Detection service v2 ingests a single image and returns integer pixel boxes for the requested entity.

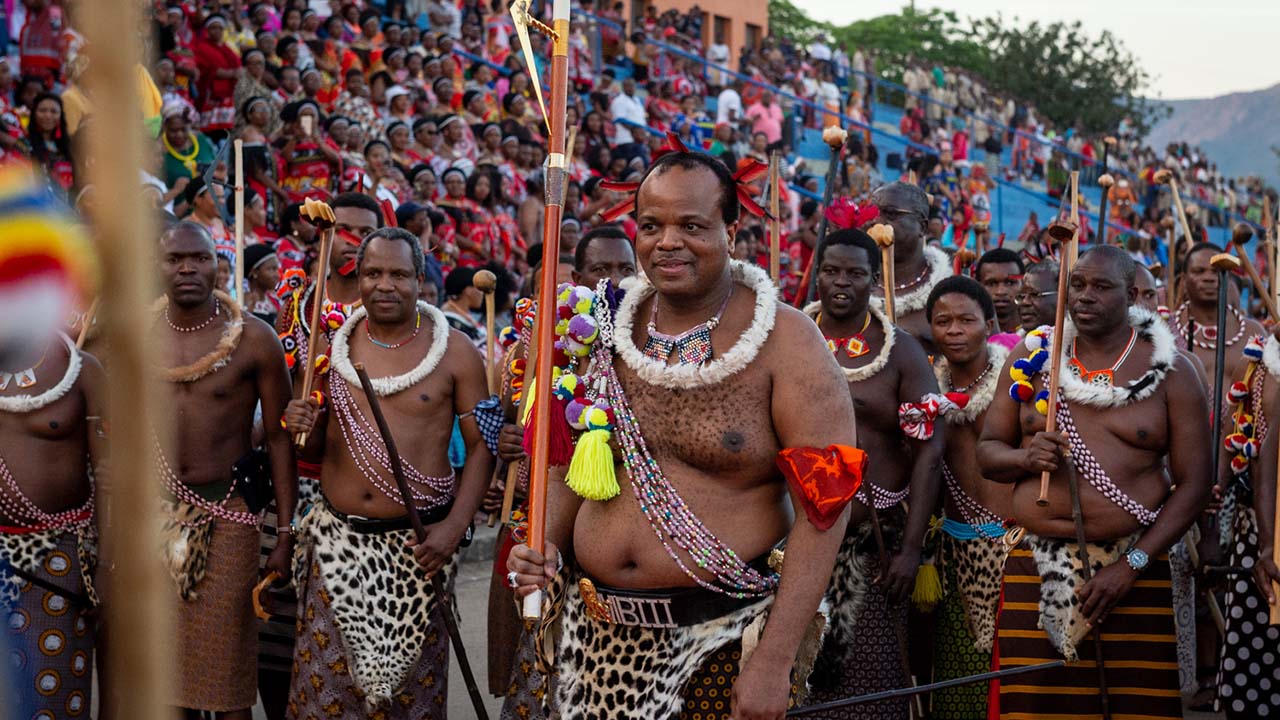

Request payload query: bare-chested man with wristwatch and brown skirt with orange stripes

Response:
[978,246,1211,717]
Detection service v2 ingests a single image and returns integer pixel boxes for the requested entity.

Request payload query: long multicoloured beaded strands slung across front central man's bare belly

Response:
[593,328,778,598]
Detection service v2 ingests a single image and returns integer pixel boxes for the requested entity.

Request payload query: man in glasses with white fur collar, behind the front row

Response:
[872,182,952,351]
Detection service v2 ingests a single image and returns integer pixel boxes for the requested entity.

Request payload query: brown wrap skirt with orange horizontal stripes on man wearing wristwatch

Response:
[997,541,1183,720]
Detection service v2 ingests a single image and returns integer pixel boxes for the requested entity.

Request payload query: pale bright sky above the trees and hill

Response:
[794,0,1280,100]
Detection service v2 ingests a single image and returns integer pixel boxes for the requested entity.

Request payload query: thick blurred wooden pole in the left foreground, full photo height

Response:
[77,1,177,720]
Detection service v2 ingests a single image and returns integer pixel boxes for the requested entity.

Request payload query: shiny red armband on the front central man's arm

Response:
[777,445,867,530]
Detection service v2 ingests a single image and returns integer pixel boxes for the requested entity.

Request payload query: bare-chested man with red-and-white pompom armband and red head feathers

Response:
[805,229,945,717]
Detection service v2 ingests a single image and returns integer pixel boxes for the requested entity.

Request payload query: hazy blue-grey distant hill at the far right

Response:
[1148,85,1280,184]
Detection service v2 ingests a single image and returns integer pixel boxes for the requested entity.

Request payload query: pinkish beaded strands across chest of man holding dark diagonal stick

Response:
[329,361,457,510]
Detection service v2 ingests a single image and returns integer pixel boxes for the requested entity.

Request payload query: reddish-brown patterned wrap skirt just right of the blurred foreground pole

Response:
[173,496,261,712]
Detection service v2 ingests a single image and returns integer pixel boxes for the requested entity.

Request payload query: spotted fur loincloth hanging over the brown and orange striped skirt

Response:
[1027,533,1139,662]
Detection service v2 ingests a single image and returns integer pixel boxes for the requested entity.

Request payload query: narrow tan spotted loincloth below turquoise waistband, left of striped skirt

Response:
[943,536,1010,652]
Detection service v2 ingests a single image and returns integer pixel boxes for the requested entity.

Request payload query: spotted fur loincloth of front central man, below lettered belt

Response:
[556,585,773,720]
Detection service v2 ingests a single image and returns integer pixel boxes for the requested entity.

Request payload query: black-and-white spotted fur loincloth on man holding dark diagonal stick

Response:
[293,502,458,711]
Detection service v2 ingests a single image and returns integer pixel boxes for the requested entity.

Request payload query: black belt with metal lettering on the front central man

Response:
[577,545,772,628]
